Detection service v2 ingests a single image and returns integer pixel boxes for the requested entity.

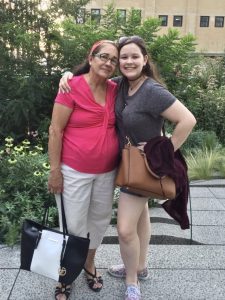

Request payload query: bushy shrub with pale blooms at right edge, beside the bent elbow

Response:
[174,57,225,145]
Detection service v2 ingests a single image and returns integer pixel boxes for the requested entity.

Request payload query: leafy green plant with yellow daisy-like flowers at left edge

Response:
[0,137,57,245]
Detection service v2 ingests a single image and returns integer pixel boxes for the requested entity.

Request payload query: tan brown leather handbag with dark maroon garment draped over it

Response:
[115,142,176,199]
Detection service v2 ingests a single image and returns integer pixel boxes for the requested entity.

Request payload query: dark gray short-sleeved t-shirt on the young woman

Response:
[115,78,176,147]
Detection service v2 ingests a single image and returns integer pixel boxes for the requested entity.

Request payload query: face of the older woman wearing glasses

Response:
[89,43,118,78]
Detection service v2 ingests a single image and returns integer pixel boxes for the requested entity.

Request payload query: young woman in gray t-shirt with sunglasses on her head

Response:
[60,36,196,300]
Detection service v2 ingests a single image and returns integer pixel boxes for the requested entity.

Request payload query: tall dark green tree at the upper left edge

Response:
[0,0,88,138]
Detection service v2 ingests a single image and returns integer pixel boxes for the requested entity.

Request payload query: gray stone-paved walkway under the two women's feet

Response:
[0,180,225,300]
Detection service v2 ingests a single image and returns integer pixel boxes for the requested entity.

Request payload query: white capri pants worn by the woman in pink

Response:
[55,164,116,249]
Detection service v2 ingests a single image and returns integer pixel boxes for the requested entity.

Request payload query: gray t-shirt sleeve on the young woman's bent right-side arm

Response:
[144,82,176,117]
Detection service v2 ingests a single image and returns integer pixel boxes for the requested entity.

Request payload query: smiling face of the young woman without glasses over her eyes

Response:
[119,43,148,80]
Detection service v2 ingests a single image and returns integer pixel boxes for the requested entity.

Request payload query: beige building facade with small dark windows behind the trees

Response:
[86,0,225,55]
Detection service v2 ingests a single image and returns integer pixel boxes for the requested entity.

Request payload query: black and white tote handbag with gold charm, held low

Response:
[20,195,90,284]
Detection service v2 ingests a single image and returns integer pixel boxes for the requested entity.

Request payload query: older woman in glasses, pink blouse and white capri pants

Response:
[48,40,119,300]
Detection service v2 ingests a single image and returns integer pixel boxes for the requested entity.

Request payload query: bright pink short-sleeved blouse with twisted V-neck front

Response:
[55,75,119,174]
